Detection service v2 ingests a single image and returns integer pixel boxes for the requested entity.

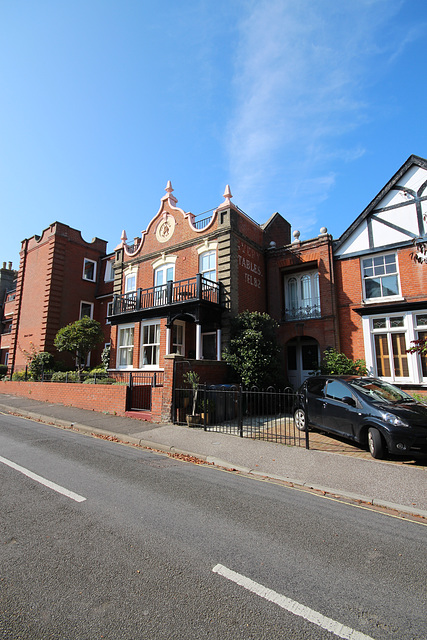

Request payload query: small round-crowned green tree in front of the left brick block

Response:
[54,316,104,370]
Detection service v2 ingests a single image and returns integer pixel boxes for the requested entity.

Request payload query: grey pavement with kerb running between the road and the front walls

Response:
[0,394,427,518]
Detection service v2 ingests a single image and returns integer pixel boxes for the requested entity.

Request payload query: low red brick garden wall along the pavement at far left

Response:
[0,381,127,416]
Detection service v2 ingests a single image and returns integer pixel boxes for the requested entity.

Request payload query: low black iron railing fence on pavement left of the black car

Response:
[172,384,309,449]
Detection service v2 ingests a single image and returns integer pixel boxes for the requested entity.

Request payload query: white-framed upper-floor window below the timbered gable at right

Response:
[362,253,400,300]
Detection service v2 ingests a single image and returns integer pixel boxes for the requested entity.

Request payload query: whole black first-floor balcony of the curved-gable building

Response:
[108,274,221,324]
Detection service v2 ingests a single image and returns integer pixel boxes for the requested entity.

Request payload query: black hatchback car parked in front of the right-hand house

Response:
[294,376,427,458]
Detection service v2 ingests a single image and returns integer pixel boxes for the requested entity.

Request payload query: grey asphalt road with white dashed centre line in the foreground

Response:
[0,415,427,640]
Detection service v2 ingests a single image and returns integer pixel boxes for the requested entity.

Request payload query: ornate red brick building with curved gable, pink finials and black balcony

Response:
[110,182,290,372]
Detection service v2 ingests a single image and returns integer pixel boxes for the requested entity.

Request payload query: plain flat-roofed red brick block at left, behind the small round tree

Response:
[1,222,113,371]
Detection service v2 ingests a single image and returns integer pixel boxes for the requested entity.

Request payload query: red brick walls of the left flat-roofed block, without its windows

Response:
[10,222,112,370]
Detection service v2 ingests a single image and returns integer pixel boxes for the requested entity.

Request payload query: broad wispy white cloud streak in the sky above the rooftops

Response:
[228,0,414,234]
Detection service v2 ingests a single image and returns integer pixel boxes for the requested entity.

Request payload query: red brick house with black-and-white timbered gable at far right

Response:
[334,156,427,386]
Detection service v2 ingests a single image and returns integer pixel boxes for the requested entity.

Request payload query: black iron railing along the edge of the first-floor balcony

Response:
[112,273,220,316]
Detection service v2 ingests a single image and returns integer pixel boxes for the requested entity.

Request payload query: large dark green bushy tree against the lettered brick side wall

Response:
[223,311,283,387]
